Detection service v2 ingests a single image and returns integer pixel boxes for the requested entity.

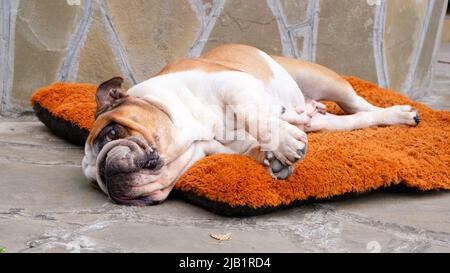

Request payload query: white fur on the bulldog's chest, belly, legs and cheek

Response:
[83,45,417,200]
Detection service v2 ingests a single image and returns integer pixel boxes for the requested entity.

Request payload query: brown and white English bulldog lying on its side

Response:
[82,44,420,205]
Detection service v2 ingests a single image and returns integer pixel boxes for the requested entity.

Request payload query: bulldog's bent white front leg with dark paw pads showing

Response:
[227,85,307,179]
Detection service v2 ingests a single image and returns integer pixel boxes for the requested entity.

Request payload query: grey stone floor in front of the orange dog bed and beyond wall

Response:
[0,45,450,252]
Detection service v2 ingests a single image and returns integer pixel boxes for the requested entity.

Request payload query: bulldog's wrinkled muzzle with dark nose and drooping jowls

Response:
[97,137,164,206]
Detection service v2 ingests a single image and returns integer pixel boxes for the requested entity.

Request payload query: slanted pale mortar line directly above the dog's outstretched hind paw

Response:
[402,0,435,95]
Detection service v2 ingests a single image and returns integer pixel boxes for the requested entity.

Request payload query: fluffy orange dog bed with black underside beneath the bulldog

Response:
[31,77,450,216]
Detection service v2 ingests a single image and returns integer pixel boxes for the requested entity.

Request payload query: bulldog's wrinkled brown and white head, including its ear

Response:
[82,78,175,205]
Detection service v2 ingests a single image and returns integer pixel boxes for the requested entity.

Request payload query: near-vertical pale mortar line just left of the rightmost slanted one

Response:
[373,0,390,88]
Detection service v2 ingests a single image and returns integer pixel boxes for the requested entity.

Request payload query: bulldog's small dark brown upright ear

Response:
[95,77,128,117]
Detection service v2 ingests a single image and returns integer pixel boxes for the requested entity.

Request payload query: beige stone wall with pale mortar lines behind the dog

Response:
[0,0,447,115]
